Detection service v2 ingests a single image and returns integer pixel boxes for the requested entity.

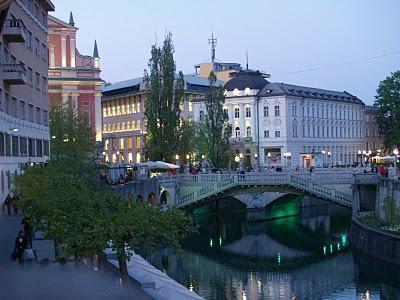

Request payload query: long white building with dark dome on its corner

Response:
[194,70,365,167]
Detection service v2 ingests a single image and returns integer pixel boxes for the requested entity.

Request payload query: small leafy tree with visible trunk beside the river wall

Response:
[103,194,195,282]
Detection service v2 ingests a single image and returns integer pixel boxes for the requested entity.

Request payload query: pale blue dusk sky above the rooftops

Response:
[53,0,400,104]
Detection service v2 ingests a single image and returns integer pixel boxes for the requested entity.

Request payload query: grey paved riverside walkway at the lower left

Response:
[0,210,152,300]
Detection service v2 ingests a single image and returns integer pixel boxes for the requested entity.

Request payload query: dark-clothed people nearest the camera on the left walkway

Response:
[11,217,36,266]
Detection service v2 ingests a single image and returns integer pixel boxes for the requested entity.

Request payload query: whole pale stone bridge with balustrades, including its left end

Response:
[113,170,354,208]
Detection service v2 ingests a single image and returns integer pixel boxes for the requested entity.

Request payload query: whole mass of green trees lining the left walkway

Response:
[15,101,194,282]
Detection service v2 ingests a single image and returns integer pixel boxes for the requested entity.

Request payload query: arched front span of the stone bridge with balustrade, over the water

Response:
[175,173,353,208]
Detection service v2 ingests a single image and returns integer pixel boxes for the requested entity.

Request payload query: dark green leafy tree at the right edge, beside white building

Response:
[374,71,400,150]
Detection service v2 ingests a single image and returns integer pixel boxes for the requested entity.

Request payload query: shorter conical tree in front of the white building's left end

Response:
[197,72,232,168]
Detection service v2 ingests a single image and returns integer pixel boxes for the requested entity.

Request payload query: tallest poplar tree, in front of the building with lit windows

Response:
[144,33,184,162]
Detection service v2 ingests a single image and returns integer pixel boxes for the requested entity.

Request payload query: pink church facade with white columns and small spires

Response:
[48,13,104,141]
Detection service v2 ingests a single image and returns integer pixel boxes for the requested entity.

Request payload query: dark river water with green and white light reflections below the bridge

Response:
[149,195,400,299]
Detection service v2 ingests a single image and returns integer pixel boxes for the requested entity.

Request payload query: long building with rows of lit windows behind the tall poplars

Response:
[102,75,217,164]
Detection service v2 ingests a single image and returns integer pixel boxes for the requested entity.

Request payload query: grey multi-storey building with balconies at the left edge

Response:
[0,0,54,202]
